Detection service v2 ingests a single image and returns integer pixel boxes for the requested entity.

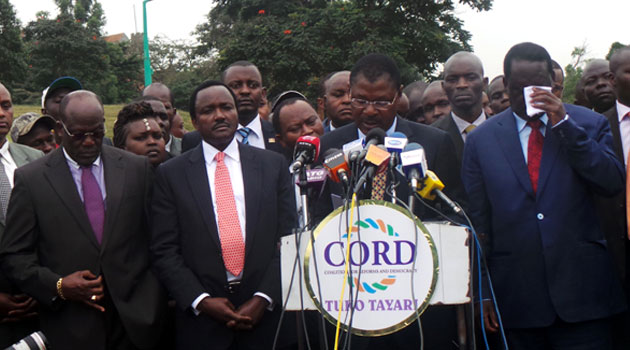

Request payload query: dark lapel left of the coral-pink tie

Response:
[184,143,221,250]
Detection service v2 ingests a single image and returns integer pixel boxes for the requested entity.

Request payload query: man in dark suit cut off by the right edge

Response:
[596,47,630,349]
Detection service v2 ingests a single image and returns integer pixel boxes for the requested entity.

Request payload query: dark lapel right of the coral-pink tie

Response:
[238,143,262,260]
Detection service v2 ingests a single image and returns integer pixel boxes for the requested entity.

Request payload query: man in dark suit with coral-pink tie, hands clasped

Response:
[151,81,296,349]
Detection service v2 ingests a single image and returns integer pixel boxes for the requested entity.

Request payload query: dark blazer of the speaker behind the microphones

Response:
[315,117,464,220]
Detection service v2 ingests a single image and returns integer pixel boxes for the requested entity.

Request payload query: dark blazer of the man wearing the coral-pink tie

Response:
[151,144,296,349]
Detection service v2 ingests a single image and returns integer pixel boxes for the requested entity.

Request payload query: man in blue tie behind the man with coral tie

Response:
[182,61,282,153]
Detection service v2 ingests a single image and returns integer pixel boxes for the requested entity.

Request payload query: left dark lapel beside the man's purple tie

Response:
[44,148,100,249]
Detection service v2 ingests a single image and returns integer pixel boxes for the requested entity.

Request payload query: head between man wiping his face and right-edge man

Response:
[580,59,616,113]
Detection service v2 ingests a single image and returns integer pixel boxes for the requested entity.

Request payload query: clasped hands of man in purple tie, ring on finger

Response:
[61,270,105,312]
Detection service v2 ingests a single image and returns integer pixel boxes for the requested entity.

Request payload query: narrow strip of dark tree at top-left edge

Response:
[0,0,26,89]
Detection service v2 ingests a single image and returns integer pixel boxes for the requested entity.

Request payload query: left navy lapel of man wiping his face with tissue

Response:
[493,108,534,195]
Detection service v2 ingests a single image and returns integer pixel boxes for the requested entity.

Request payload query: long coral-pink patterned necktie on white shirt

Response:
[214,152,245,276]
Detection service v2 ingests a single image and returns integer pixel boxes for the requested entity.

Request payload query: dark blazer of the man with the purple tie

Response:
[0,146,165,349]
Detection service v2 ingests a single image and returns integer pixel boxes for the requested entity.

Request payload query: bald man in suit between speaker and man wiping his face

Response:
[431,51,487,164]
